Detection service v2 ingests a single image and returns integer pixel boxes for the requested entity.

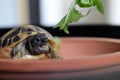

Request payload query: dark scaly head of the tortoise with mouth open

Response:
[27,33,50,55]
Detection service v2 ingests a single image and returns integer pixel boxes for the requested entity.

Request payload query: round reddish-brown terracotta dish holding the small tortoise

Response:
[0,38,120,80]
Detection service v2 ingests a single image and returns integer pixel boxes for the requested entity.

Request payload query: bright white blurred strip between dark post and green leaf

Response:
[40,0,62,26]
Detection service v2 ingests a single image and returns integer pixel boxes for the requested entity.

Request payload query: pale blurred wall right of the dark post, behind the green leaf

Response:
[40,0,120,26]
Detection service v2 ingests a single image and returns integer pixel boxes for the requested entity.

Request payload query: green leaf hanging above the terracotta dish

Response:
[55,0,104,34]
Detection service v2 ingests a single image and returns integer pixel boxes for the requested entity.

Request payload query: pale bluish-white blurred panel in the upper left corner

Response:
[0,0,18,27]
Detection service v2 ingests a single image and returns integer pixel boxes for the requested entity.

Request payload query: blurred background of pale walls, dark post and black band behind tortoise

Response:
[0,0,120,36]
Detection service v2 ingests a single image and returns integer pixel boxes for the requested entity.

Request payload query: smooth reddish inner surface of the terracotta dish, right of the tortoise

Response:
[60,38,120,59]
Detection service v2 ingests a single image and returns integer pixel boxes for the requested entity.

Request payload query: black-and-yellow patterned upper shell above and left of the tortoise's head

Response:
[0,25,37,48]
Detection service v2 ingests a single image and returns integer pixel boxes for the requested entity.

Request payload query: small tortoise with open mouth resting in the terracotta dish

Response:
[0,25,61,59]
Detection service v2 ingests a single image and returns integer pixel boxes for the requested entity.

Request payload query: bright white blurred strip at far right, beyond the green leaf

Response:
[104,0,120,25]
